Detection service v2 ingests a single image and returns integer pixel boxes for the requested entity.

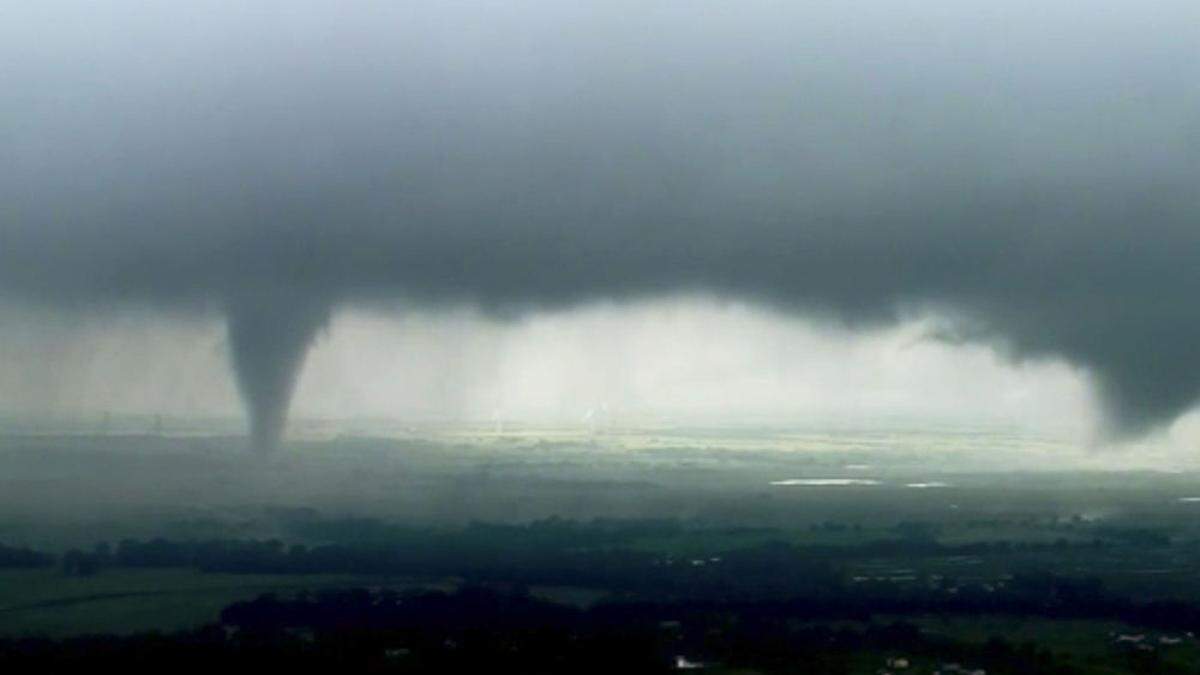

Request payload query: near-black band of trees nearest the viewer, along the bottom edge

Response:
[0,587,1142,675]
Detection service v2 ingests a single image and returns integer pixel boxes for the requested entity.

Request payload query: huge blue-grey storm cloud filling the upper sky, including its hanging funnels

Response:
[0,1,1200,444]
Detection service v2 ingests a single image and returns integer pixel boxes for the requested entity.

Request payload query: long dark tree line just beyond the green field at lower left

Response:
[54,525,1123,578]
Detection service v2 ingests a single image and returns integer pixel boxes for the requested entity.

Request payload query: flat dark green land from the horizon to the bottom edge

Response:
[0,428,1200,674]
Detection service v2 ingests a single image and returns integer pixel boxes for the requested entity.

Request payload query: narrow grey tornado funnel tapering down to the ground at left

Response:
[227,291,330,453]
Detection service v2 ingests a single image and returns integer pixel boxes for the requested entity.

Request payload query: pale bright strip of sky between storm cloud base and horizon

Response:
[0,298,1093,422]
